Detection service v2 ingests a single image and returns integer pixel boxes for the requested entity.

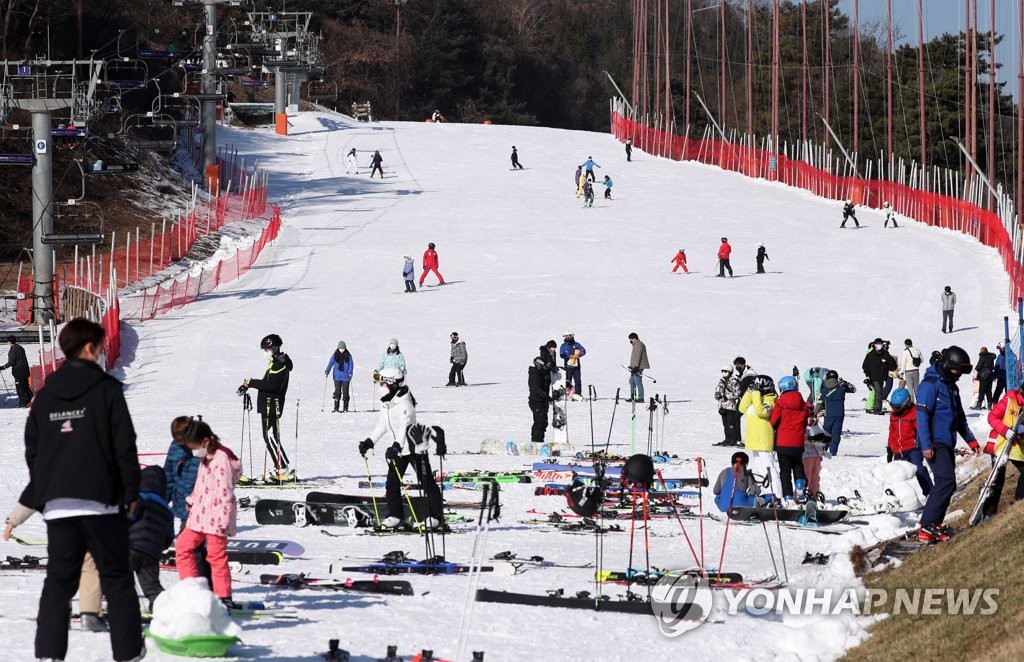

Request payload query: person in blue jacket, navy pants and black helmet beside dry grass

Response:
[918,345,982,542]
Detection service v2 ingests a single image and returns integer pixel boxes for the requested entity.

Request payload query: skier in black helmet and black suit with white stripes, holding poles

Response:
[239,333,295,482]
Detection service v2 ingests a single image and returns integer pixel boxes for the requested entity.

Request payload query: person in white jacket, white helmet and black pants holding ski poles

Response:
[359,367,447,529]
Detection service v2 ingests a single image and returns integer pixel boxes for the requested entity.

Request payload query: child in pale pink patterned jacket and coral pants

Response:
[174,420,242,605]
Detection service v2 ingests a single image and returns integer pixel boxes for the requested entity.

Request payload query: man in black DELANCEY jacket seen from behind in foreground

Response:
[20,318,145,660]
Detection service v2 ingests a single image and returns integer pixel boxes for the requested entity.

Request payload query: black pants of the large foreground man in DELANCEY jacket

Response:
[36,514,142,660]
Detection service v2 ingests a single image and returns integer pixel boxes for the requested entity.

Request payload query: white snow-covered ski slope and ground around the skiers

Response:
[0,113,1007,660]
